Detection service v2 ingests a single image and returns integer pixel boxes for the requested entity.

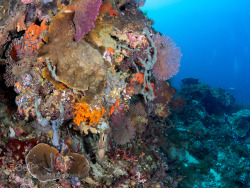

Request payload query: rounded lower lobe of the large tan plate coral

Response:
[52,42,106,93]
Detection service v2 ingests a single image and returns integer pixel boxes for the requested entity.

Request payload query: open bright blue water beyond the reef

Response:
[142,0,250,105]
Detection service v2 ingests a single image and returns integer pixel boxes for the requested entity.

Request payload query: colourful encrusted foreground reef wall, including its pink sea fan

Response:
[0,0,184,187]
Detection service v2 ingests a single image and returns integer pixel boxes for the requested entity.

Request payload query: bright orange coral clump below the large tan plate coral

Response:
[73,103,105,125]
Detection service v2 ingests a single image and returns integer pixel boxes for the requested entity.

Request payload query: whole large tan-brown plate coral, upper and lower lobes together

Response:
[39,12,106,93]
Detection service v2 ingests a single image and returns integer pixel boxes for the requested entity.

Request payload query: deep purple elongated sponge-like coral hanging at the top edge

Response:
[73,0,102,41]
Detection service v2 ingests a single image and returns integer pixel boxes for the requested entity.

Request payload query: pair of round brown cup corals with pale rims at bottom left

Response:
[26,143,89,181]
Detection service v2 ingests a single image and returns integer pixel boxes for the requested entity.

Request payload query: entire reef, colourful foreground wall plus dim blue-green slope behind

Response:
[0,0,250,188]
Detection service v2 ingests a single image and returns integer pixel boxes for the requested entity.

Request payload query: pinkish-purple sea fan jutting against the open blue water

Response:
[153,33,182,80]
